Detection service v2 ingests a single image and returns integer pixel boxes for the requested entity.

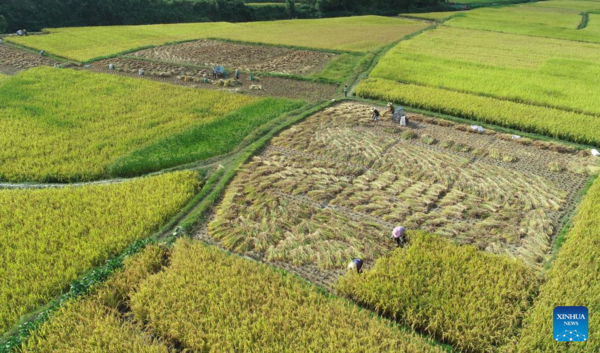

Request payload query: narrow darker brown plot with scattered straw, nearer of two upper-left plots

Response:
[91,58,337,101]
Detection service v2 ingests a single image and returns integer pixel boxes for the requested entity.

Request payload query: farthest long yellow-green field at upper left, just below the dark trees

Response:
[8,16,427,61]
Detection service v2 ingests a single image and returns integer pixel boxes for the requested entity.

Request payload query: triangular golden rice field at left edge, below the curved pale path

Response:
[0,172,200,332]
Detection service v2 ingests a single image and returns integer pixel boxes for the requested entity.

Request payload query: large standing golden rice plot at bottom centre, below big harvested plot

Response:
[131,239,442,352]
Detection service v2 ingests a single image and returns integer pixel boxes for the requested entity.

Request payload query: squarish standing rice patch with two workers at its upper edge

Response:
[338,233,537,352]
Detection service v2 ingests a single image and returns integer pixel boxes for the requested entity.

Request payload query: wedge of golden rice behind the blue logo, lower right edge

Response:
[515,179,600,352]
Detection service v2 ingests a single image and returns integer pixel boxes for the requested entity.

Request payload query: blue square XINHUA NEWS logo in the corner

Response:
[554,306,589,342]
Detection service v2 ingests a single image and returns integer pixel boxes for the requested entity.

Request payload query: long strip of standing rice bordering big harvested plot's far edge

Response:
[355,78,600,146]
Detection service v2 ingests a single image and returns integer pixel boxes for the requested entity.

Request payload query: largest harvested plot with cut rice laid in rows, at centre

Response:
[206,103,594,286]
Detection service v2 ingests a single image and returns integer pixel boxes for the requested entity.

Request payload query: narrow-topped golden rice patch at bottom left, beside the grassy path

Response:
[22,245,171,353]
